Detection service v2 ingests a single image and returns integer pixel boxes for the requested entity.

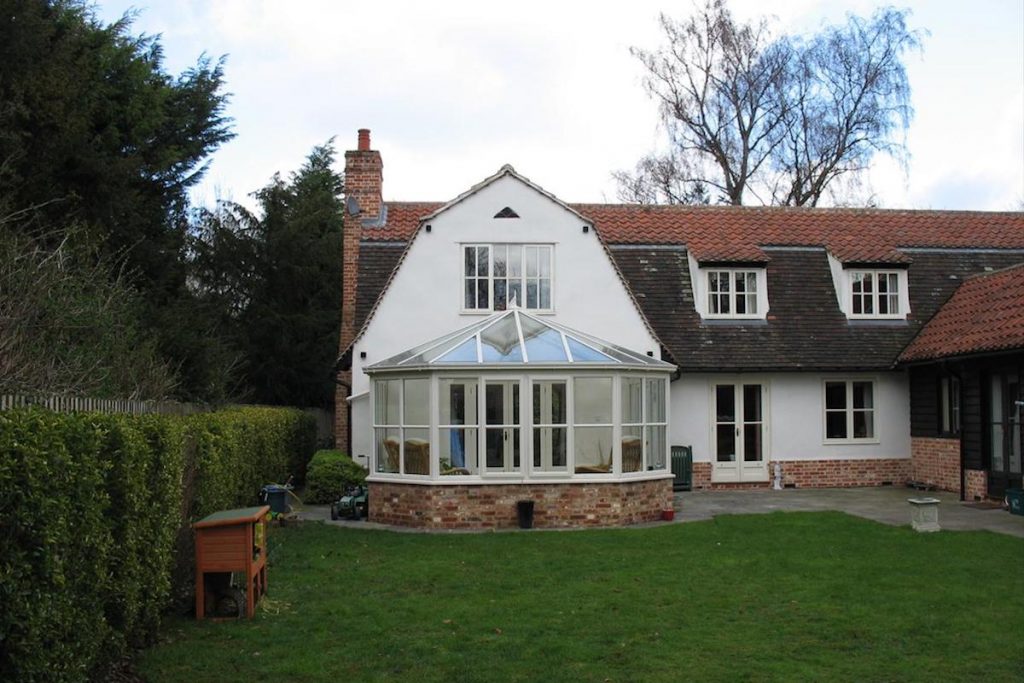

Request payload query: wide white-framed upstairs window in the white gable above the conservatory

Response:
[462,245,553,312]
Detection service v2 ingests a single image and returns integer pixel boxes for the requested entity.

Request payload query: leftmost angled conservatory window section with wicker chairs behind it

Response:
[374,378,430,475]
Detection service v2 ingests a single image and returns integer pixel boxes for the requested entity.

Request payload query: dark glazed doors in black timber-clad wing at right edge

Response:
[987,372,1024,496]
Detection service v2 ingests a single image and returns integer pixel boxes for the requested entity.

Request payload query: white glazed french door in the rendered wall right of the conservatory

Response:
[712,382,768,482]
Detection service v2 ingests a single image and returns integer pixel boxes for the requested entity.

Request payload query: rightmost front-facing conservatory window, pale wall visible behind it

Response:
[572,377,612,474]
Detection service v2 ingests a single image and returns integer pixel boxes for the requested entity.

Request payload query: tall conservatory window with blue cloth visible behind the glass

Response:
[437,378,479,476]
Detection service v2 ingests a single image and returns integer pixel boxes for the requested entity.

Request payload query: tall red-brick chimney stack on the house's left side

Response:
[334,128,387,456]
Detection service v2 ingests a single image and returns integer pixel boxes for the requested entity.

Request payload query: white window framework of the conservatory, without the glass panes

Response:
[370,369,671,484]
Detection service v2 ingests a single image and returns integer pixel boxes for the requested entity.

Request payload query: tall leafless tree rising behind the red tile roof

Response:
[613,0,920,206]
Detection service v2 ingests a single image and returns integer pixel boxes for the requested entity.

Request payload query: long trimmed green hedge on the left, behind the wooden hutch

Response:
[0,408,315,681]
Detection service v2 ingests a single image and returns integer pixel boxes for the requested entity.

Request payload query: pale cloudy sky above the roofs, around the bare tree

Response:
[98,0,1024,210]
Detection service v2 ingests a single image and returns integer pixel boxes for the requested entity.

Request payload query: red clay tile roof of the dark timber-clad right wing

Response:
[899,263,1024,361]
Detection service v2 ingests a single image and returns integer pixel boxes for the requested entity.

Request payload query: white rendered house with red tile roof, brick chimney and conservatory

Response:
[336,130,1024,527]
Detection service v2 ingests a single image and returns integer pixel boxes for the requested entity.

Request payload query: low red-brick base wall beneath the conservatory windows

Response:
[369,479,672,529]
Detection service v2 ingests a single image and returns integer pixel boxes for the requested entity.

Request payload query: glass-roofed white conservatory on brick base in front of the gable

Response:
[366,309,675,527]
